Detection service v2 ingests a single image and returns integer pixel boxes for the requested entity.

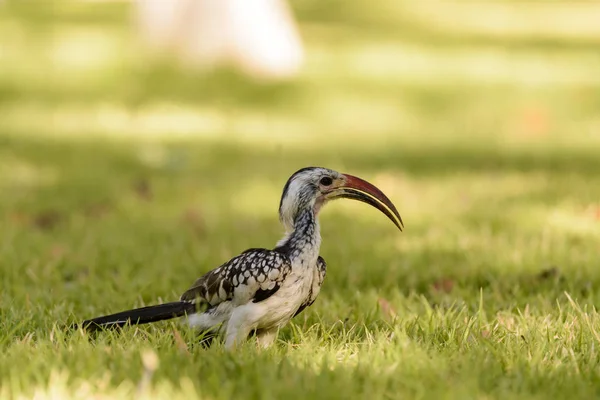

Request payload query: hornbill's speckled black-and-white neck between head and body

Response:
[275,207,321,264]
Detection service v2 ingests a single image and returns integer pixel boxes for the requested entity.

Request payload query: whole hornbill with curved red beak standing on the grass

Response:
[80,167,403,349]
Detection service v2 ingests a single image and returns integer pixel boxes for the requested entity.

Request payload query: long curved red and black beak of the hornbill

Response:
[327,174,404,230]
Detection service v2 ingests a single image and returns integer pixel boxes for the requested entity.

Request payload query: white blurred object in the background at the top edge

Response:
[136,0,304,79]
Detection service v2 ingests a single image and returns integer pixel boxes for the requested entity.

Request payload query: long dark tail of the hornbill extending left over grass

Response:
[75,301,196,331]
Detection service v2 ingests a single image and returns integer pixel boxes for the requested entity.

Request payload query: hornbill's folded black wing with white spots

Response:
[181,249,292,307]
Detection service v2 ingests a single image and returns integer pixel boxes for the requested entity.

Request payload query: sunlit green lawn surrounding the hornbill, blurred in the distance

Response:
[0,0,600,399]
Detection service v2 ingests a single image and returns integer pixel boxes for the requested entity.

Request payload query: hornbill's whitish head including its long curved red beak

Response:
[279,167,403,231]
